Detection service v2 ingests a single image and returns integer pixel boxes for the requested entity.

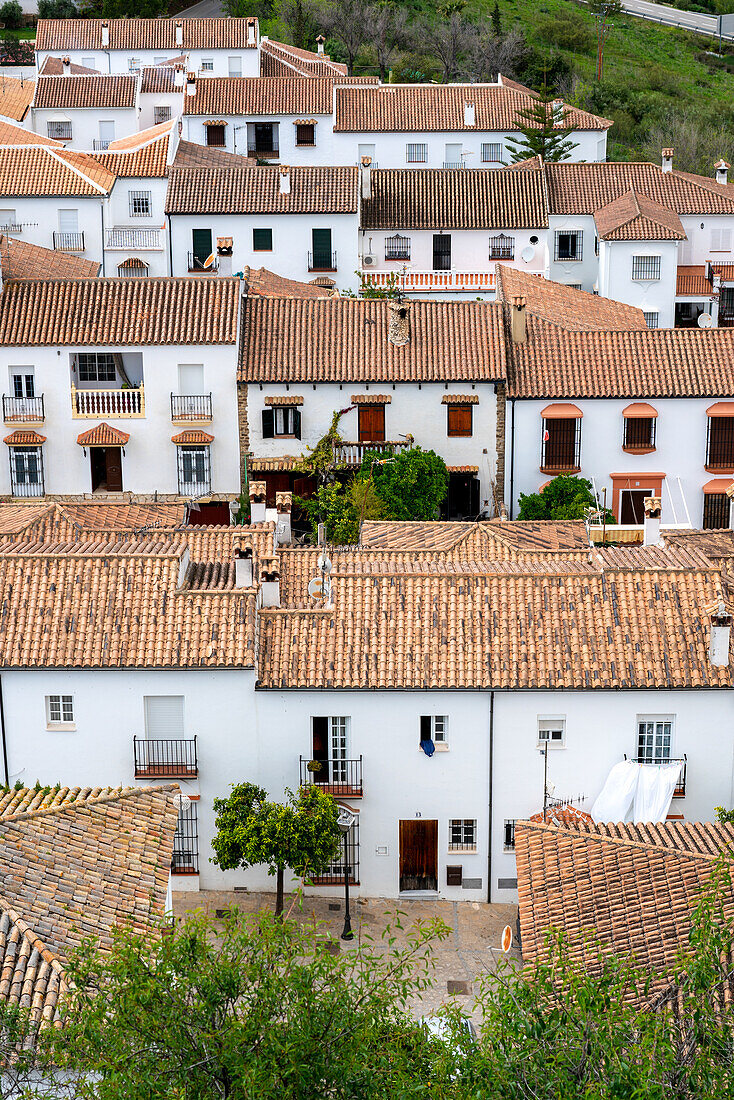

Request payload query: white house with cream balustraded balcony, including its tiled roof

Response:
[0,278,240,503]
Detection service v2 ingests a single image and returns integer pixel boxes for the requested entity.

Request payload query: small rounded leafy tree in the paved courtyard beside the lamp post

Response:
[211,783,341,916]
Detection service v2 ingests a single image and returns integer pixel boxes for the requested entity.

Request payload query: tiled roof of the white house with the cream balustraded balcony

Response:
[0,278,240,347]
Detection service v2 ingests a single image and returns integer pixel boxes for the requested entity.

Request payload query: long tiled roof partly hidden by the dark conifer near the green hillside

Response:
[335,84,612,132]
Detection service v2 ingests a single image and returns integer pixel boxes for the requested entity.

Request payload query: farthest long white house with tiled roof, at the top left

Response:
[35,18,260,76]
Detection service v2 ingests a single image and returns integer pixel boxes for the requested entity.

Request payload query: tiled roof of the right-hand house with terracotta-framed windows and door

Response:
[507,314,734,398]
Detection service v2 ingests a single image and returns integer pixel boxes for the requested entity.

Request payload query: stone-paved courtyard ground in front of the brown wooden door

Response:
[174,890,519,1023]
